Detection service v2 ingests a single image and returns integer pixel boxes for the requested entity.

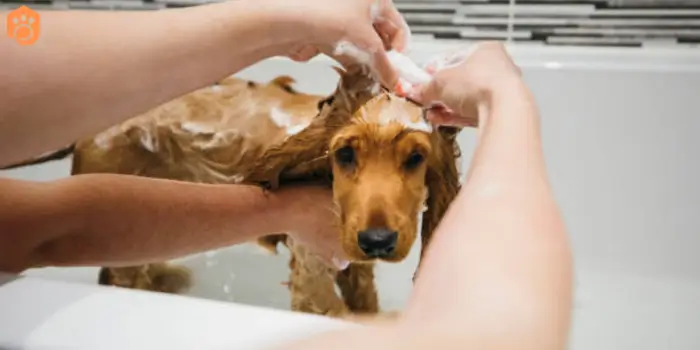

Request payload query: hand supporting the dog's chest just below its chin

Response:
[276,185,349,270]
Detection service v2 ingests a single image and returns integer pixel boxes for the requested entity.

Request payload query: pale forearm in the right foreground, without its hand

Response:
[407,83,571,349]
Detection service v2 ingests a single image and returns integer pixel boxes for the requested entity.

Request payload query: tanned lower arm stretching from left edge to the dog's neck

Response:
[0,174,332,272]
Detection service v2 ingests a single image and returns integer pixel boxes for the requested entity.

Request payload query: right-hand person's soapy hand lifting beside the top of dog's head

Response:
[409,42,522,126]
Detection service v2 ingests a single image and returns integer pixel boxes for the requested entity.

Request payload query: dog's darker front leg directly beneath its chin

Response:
[336,263,379,314]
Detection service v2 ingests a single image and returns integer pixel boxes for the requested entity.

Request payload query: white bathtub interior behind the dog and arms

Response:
[0,44,700,350]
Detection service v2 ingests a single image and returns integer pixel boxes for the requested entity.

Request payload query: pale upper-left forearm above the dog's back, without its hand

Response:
[0,0,294,165]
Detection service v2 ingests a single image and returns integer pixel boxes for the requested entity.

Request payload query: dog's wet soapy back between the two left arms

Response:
[72,76,321,183]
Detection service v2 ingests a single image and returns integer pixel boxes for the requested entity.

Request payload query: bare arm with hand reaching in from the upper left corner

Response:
[0,0,408,165]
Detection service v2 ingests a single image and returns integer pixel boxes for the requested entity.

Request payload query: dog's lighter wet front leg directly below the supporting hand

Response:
[289,244,349,317]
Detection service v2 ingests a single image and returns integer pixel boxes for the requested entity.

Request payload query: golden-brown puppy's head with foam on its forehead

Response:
[328,66,455,262]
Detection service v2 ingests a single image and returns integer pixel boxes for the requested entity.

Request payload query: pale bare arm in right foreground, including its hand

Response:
[276,44,572,350]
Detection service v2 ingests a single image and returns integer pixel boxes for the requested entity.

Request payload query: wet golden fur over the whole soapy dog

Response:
[30,65,459,316]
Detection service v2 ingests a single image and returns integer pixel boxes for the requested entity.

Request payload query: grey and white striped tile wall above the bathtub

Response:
[0,0,700,48]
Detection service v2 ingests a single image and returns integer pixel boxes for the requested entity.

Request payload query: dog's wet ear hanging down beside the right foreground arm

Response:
[413,128,461,280]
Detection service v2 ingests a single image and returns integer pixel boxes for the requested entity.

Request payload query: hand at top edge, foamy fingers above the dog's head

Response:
[271,0,410,86]
